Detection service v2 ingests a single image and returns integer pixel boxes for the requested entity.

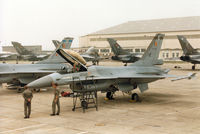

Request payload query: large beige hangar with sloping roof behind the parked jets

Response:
[79,16,200,60]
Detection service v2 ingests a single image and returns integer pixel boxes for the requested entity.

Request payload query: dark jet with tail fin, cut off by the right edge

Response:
[177,35,200,70]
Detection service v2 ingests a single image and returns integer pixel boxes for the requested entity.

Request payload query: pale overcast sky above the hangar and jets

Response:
[0,0,200,50]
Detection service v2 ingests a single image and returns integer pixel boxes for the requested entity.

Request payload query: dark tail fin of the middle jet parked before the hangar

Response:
[107,38,128,56]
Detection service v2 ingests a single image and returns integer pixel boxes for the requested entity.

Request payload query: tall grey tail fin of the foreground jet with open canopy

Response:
[131,34,165,66]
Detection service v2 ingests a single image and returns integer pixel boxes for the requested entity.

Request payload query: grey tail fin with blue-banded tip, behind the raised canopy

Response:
[37,37,73,64]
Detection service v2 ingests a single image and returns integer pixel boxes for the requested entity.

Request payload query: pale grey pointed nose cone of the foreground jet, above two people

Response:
[27,76,53,88]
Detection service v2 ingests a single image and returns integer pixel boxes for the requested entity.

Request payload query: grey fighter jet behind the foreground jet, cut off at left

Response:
[0,39,72,92]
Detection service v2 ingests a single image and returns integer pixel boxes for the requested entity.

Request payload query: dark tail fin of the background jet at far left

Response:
[11,41,32,55]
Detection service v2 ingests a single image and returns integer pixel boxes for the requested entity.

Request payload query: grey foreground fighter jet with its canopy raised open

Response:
[27,34,194,109]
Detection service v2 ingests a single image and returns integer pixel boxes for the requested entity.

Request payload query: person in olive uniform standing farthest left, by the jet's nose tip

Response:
[23,88,33,119]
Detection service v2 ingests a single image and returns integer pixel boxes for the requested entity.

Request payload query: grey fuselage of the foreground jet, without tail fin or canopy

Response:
[28,66,166,91]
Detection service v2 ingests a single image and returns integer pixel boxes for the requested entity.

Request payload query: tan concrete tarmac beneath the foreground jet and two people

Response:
[0,62,200,134]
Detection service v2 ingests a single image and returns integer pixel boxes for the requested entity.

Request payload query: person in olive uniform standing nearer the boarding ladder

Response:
[51,83,60,116]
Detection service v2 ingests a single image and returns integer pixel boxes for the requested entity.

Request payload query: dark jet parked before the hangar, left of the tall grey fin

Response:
[107,38,163,66]
